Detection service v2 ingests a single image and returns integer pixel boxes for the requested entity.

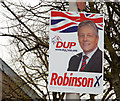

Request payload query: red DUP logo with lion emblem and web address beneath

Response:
[52,36,77,52]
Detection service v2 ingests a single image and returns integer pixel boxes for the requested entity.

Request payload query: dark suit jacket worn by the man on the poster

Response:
[67,48,102,73]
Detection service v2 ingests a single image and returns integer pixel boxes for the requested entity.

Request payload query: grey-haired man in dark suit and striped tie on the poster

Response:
[67,20,102,73]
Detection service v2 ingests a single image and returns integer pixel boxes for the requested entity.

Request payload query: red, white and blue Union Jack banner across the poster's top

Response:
[50,11,103,33]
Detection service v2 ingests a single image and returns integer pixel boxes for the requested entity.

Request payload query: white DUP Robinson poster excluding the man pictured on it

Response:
[48,11,104,94]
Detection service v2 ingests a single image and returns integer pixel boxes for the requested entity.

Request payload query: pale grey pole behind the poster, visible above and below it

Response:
[66,0,79,101]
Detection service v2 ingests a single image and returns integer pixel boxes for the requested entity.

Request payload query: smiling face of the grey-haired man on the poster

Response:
[78,26,99,55]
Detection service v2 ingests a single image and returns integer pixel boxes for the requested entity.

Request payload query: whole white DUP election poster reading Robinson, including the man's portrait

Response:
[48,11,104,94]
